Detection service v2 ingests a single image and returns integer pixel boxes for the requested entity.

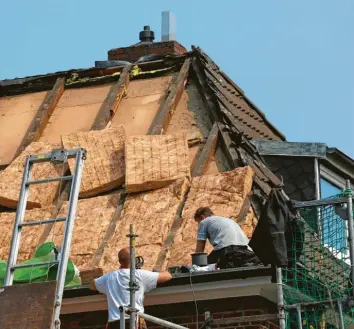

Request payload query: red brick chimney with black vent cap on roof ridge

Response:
[108,26,187,63]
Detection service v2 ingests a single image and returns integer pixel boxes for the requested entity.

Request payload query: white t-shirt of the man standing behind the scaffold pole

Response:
[95,269,159,322]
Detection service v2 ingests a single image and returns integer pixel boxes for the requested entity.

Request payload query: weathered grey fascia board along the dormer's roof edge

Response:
[252,140,327,158]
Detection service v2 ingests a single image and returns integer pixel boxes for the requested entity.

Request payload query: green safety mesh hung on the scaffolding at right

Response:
[283,191,354,329]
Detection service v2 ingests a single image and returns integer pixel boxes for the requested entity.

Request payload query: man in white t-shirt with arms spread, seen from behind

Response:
[90,248,172,329]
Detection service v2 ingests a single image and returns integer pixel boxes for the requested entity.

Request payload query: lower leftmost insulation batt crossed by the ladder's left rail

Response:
[0,207,54,263]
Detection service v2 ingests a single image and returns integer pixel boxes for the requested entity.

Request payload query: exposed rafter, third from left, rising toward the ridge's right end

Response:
[148,58,191,135]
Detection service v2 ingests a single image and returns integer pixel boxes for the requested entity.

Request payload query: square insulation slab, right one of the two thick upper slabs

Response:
[125,133,190,193]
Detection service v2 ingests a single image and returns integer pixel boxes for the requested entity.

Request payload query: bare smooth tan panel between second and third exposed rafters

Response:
[111,76,173,136]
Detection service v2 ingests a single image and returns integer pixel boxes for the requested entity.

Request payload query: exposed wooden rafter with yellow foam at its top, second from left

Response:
[91,65,132,130]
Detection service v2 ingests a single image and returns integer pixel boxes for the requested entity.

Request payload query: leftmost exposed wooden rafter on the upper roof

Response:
[14,78,65,159]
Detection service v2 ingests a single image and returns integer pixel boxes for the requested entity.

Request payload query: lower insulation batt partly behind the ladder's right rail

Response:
[47,194,120,270]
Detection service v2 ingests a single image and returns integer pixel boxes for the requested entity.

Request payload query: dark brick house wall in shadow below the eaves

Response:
[61,296,279,329]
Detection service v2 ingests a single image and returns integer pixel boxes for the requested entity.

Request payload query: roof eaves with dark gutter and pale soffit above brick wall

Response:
[61,267,276,314]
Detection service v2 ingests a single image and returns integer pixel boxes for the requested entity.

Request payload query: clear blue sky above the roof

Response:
[0,0,354,157]
